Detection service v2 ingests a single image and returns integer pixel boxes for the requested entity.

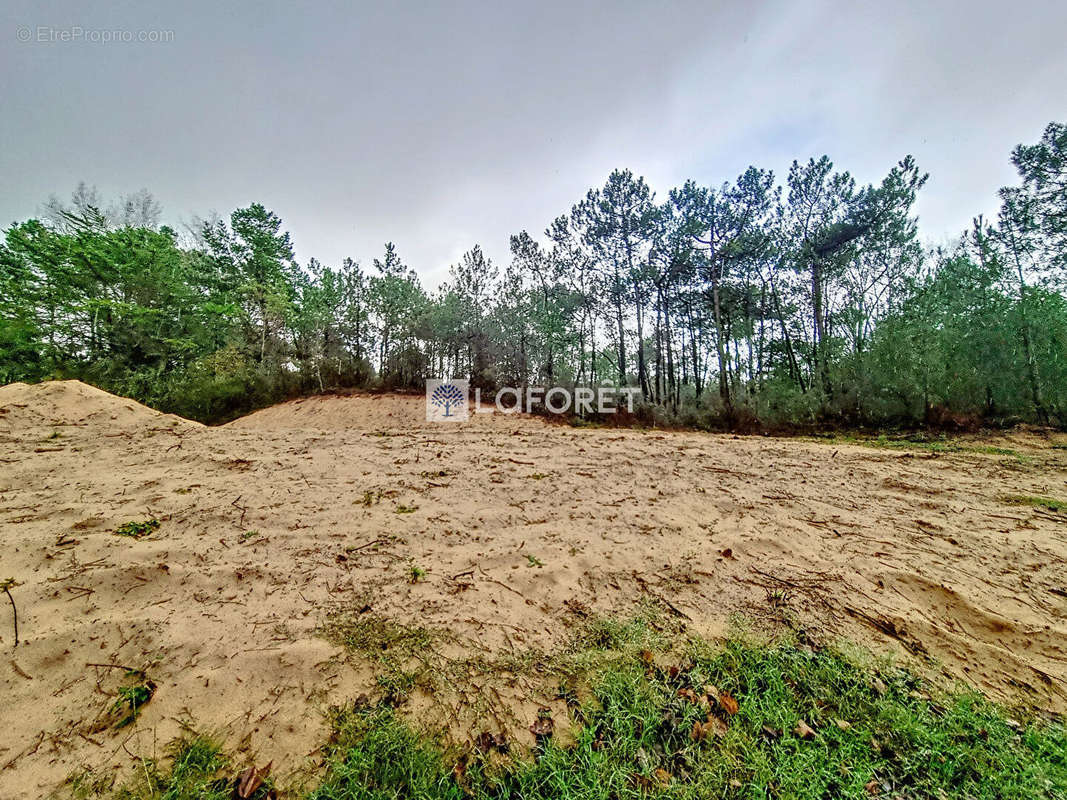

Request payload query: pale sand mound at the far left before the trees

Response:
[0,381,196,433]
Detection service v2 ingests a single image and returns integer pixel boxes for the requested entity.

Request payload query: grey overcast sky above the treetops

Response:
[0,0,1067,286]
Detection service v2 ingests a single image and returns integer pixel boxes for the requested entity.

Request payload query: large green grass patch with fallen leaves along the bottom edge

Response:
[308,631,1067,800]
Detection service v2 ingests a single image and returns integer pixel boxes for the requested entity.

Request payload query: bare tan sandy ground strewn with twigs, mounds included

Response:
[0,382,1067,800]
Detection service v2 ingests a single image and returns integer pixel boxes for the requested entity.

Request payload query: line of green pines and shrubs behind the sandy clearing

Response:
[0,123,1067,427]
